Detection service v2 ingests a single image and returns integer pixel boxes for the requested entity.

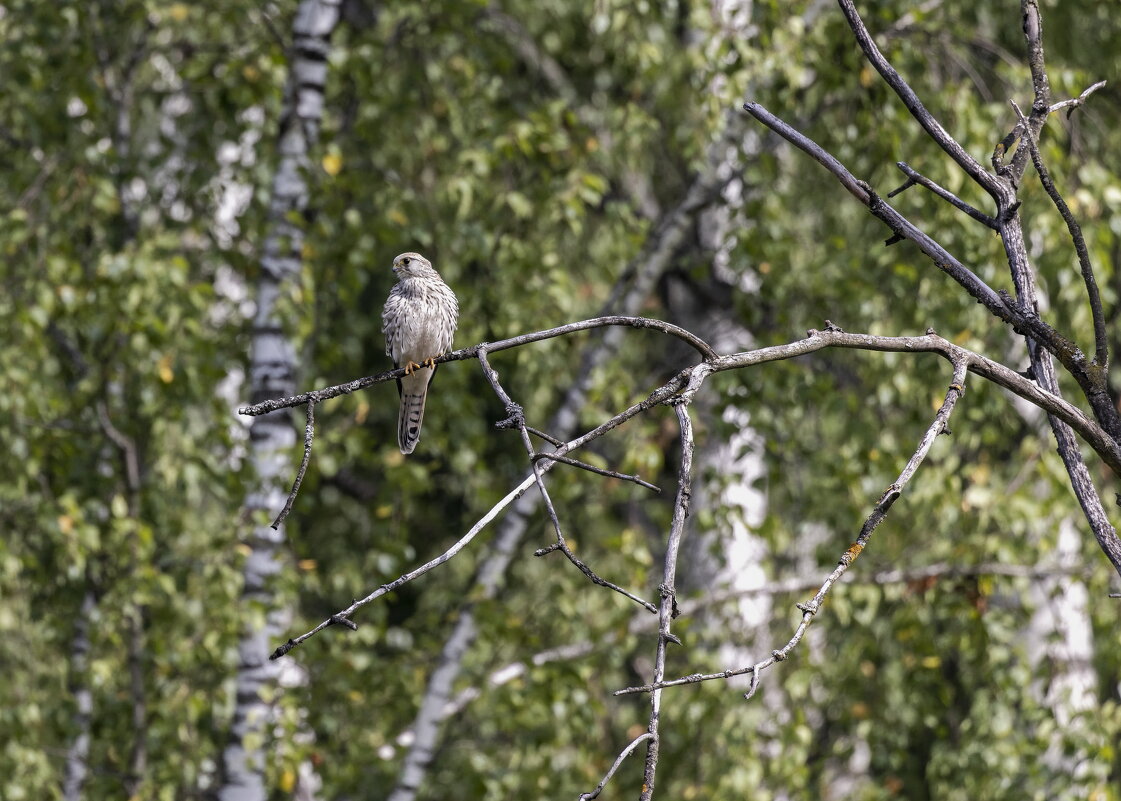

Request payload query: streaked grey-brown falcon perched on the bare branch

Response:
[381,253,460,454]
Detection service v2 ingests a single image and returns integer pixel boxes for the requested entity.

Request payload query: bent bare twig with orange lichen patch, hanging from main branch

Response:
[614,352,969,698]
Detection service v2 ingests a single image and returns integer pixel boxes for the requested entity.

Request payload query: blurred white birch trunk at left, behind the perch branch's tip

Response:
[219,0,341,801]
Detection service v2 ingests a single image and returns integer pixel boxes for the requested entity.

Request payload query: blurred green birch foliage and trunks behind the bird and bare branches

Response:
[0,0,1121,801]
